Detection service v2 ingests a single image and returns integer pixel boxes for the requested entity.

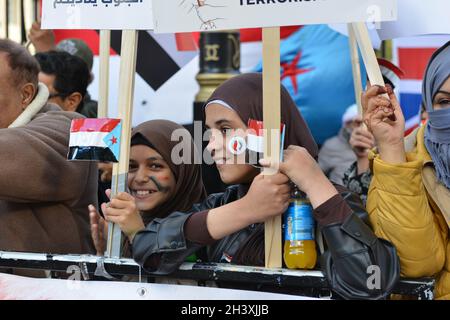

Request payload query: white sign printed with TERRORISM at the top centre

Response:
[153,0,397,33]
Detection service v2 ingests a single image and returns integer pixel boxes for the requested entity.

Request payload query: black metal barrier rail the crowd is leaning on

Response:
[0,251,435,300]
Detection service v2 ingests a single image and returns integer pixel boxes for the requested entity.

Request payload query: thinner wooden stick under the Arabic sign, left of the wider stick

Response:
[98,30,111,118]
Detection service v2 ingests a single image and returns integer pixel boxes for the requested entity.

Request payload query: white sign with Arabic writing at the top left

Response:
[42,0,153,30]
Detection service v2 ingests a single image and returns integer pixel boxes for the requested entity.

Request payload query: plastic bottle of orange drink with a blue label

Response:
[284,188,317,269]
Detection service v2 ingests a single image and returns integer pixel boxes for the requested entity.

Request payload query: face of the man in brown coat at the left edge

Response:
[0,53,27,129]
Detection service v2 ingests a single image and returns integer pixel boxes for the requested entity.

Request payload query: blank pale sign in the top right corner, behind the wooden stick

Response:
[378,0,450,40]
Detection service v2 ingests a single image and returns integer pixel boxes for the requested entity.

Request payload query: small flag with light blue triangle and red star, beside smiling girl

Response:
[67,119,122,162]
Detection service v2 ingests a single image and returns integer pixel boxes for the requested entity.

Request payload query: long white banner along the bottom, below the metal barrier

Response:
[0,272,318,300]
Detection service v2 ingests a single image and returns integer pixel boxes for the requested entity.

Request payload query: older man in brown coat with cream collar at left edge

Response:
[0,39,98,253]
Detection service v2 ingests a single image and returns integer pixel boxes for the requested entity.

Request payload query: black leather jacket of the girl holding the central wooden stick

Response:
[133,186,400,299]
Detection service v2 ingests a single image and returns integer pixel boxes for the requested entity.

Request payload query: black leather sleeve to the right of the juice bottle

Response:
[321,192,400,299]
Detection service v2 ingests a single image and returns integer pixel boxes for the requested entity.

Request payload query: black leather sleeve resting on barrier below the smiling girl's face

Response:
[132,187,241,275]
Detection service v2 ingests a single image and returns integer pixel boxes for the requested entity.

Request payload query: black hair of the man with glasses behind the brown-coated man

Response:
[35,51,91,102]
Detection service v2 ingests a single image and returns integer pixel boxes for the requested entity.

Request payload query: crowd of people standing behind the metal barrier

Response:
[0,25,450,299]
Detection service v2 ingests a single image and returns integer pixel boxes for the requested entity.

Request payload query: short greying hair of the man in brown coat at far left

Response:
[0,39,40,88]
